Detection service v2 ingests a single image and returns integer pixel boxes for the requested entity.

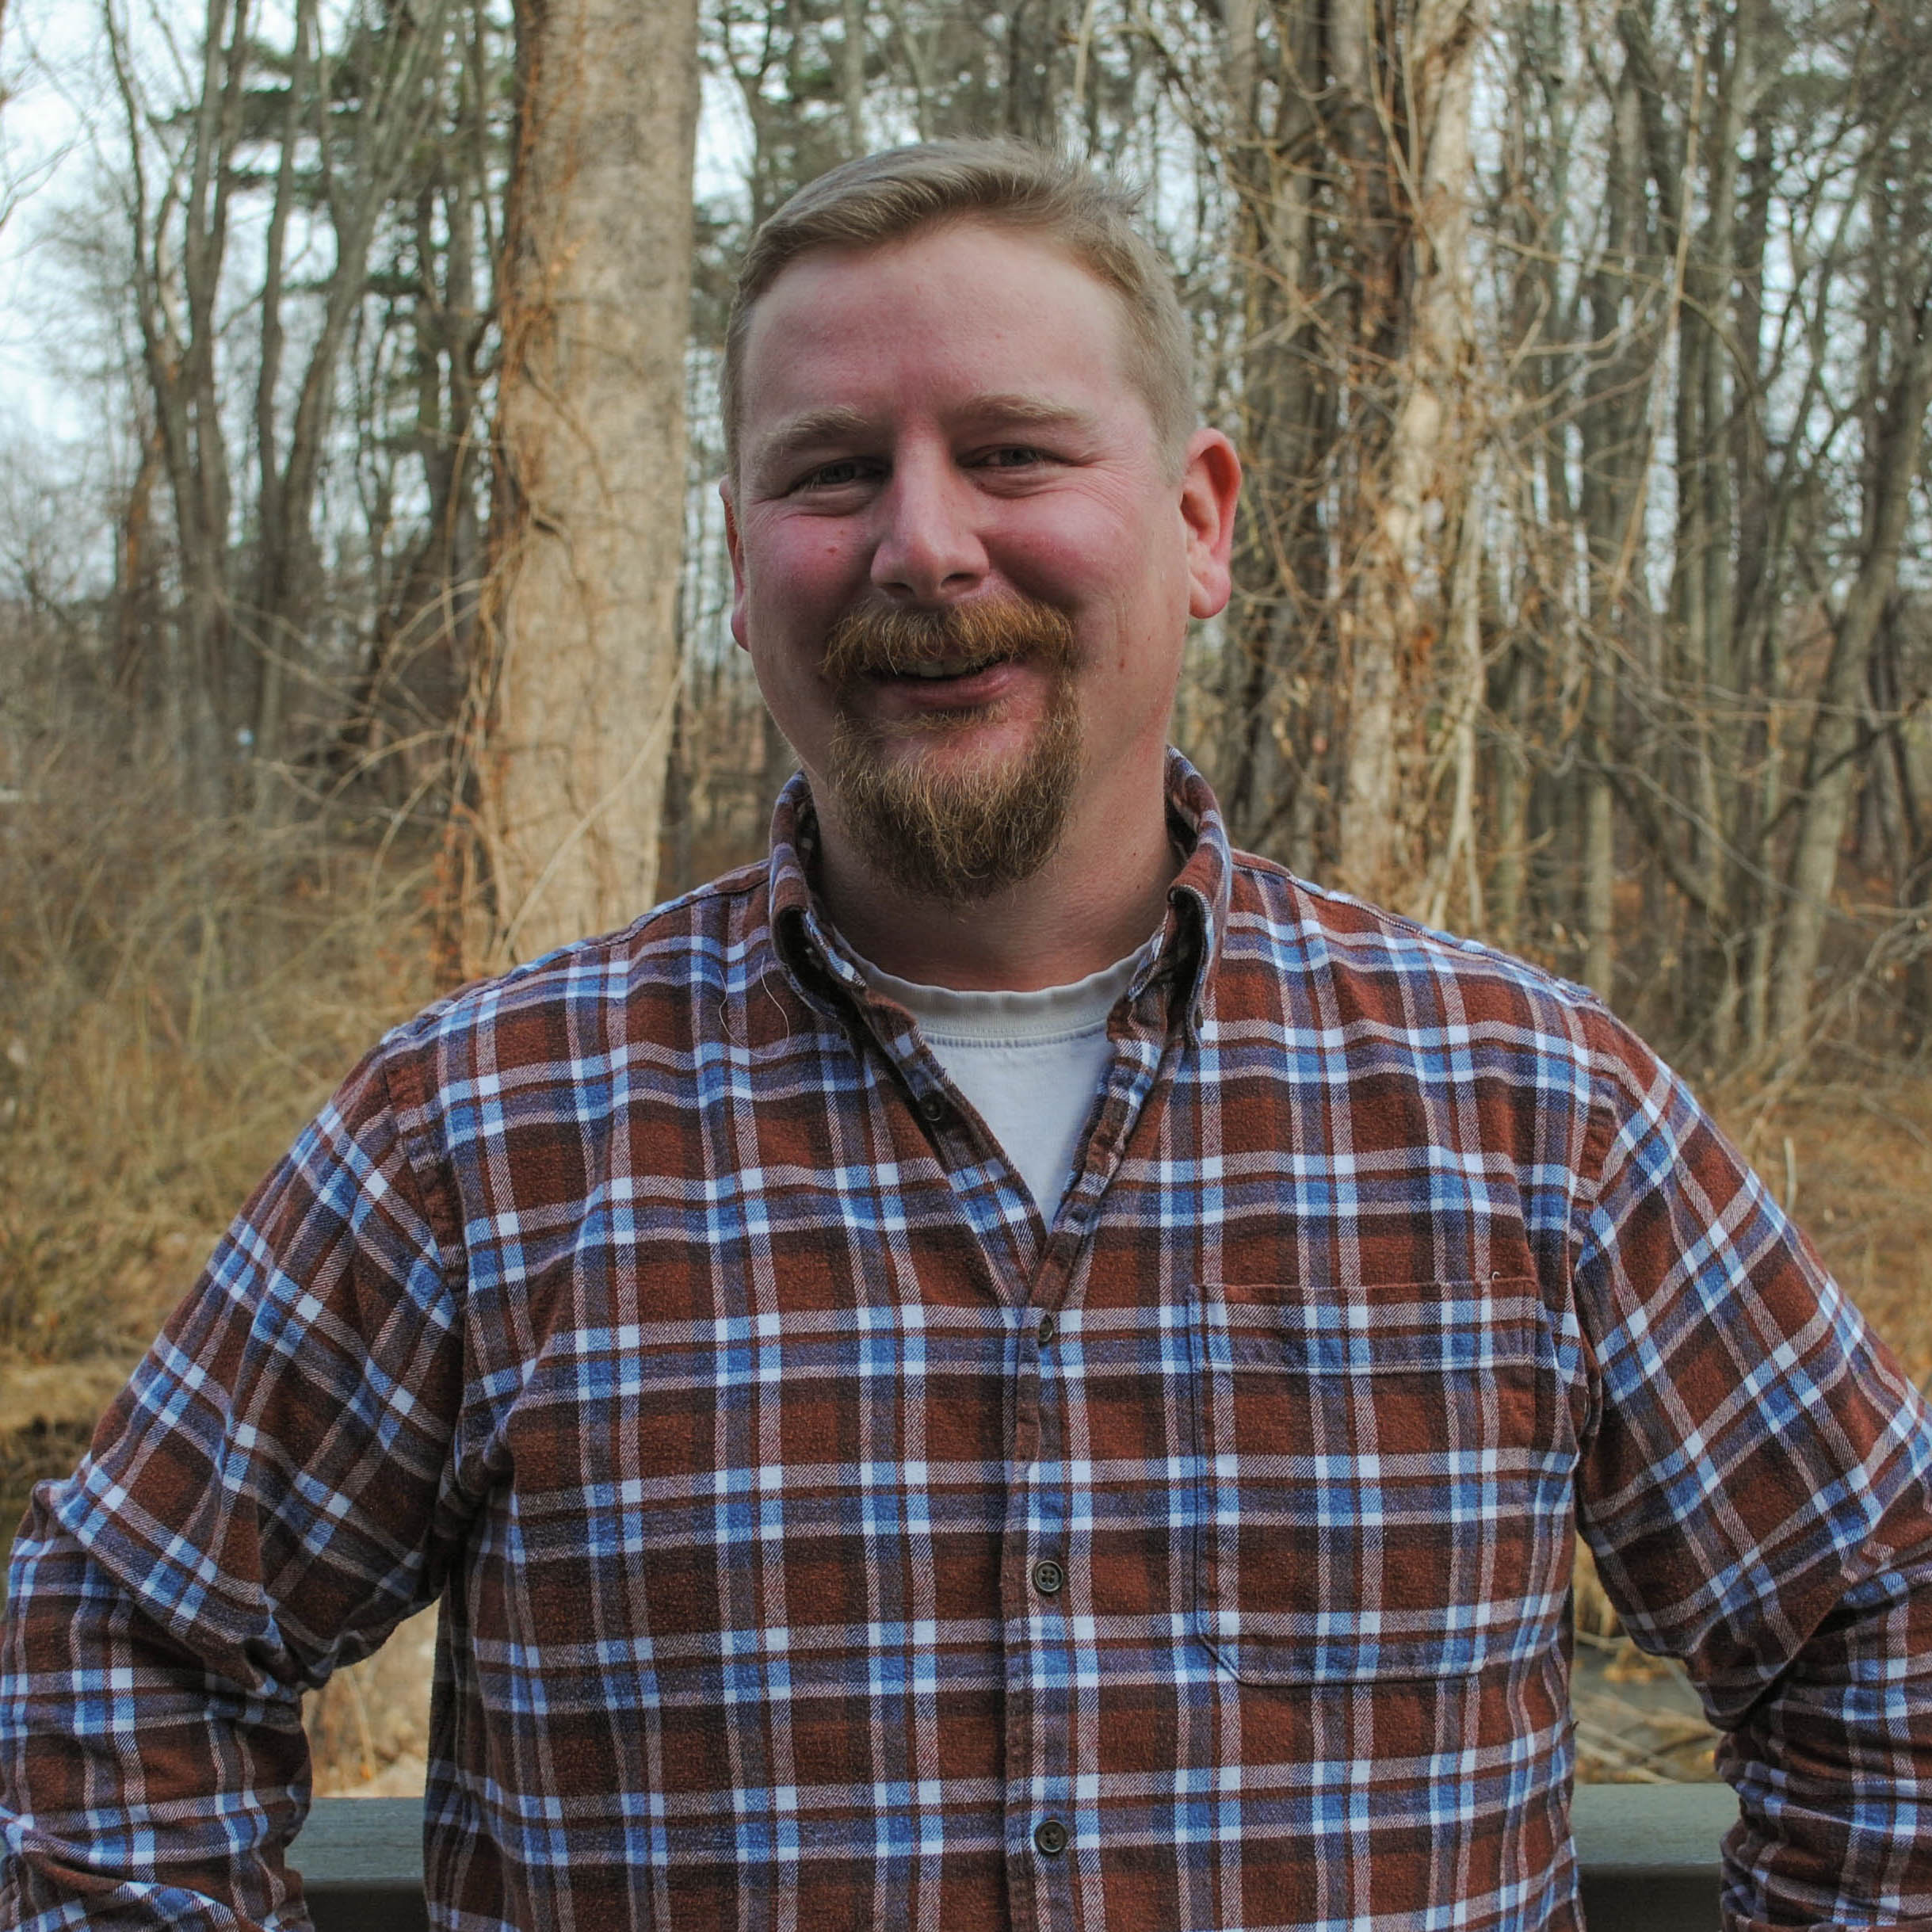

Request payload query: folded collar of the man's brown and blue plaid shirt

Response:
[769,750,1232,1028]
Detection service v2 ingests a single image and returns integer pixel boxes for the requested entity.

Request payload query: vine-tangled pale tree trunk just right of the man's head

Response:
[1204,0,1483,900]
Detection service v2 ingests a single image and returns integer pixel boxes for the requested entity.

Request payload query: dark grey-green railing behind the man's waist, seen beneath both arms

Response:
[296,1785,1737,1932]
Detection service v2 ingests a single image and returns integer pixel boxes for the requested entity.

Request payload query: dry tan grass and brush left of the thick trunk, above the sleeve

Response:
[0,740,431,1362]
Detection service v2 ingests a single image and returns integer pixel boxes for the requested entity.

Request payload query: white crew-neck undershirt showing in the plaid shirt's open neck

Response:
[846,934,1159,1227]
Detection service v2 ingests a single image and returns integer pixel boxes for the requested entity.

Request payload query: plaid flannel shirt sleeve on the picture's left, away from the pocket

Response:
[0,1049,462,1928]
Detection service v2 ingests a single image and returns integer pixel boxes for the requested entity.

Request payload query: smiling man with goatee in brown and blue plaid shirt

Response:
[0,145,1932,1932]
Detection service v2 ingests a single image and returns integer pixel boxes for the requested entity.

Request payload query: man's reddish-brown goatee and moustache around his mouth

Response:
[825,599,1080,904]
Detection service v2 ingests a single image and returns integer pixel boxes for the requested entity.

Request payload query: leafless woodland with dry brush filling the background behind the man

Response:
[0,0,1932,1785]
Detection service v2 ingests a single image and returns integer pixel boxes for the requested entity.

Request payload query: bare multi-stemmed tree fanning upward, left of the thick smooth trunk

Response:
[102,0,467,810]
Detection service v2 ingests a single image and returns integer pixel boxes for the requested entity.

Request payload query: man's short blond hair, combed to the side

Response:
[720,139,1198,475]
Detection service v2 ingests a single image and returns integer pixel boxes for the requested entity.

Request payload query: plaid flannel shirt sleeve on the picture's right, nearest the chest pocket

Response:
[1575,1037,1932,1932]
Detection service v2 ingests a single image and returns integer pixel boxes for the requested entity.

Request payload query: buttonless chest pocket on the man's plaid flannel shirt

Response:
[1192,1281,1575,1685]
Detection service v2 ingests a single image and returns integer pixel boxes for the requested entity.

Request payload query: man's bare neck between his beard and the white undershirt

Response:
[817,800,1178,993]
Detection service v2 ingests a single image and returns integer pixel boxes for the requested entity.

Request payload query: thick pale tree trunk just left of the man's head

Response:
[479,0,697,960]
